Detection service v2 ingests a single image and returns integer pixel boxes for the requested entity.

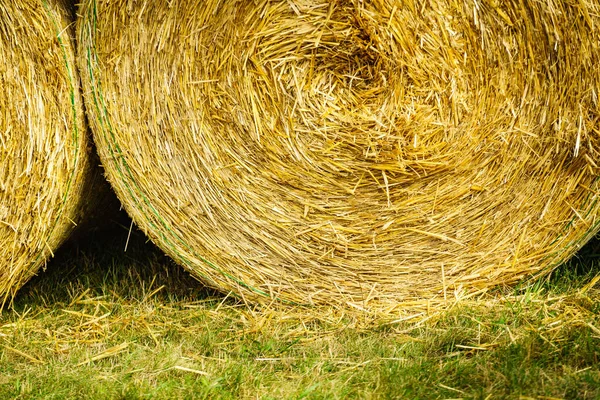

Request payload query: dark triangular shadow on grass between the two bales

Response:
[13,212,222,310]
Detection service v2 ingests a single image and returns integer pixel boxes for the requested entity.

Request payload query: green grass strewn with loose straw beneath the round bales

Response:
[0,217,600,399]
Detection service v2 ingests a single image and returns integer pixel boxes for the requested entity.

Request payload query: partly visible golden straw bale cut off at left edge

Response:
[0,0,92,306]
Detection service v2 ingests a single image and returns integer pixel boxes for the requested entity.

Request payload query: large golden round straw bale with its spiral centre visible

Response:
[78,0,600,310]
